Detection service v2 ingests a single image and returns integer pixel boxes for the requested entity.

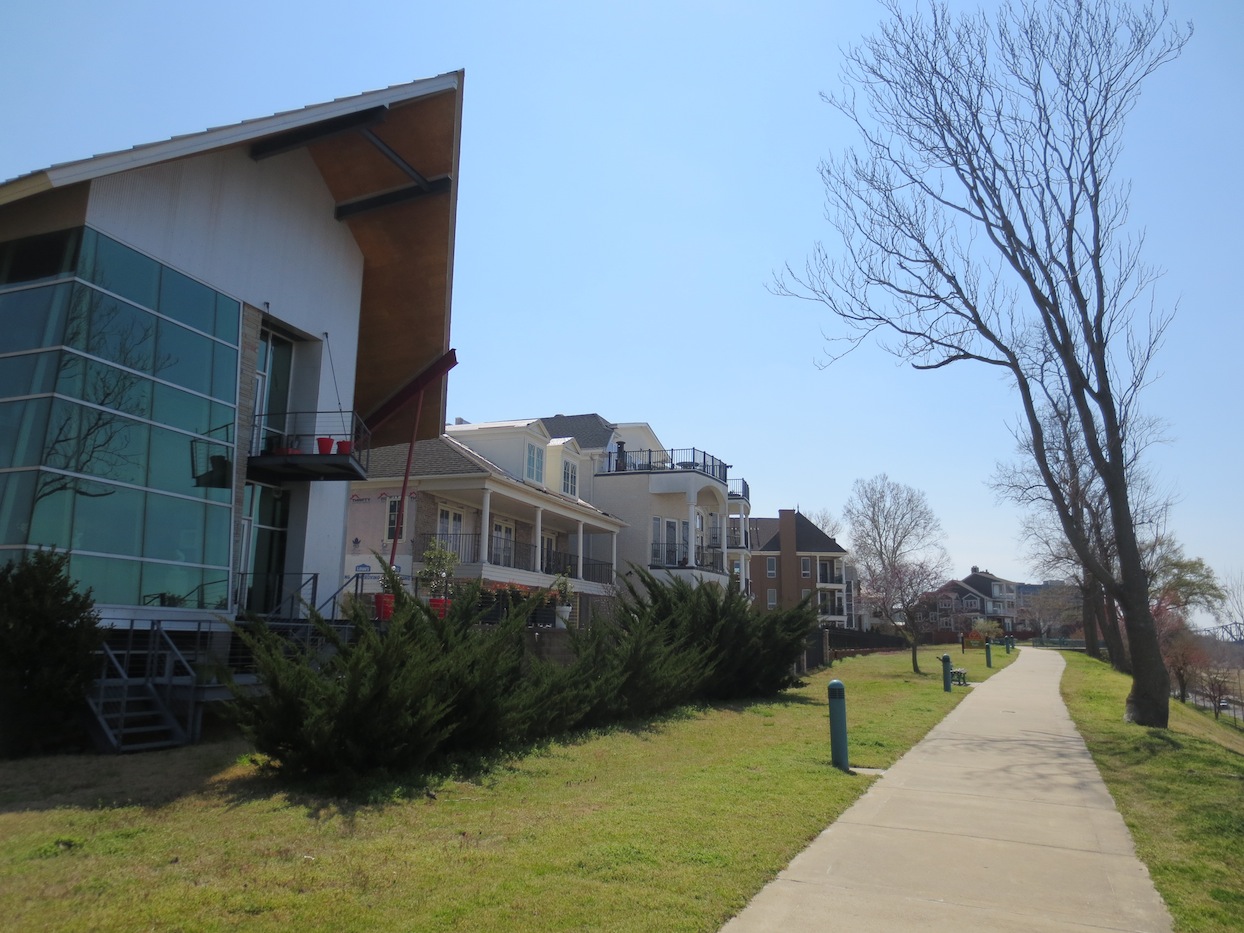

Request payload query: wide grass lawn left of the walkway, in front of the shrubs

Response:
[0,649,1000,931]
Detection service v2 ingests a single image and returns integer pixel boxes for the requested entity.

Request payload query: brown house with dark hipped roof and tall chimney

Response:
[751,509,865,628]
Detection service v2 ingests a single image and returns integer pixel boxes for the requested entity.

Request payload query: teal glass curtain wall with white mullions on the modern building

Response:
[0,228,241,610]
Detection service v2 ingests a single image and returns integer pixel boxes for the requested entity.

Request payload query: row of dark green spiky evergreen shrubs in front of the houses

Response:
[231,570,816,787]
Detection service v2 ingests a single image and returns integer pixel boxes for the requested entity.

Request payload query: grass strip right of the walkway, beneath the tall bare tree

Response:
[1062,653,1244,933]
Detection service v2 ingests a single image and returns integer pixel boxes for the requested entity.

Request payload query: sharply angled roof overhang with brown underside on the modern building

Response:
[0,71,463,445]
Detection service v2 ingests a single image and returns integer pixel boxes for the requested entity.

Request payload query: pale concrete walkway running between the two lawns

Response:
[723,648,1171,933]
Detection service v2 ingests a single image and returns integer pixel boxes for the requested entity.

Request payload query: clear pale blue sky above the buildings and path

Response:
[0,0,1244,594]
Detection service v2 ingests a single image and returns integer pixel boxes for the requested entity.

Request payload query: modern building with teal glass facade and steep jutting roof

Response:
[0,72,463,626]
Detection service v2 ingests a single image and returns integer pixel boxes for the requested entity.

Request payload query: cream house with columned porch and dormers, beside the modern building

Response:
[345,432,626,629]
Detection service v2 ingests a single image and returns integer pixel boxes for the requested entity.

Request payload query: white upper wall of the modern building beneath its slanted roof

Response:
[87,149,363,592]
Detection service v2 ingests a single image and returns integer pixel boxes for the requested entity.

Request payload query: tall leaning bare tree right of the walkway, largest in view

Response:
[778,0,1191,726]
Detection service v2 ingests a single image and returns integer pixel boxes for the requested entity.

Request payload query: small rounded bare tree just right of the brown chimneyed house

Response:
[842,473,948,674]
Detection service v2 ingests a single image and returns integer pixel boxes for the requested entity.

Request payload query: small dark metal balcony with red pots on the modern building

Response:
[248,412,372,480]
